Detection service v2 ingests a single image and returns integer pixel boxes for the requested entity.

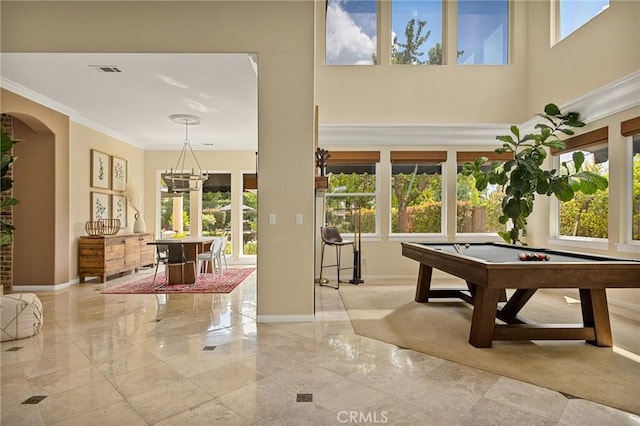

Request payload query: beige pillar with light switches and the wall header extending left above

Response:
[1,1,314,321]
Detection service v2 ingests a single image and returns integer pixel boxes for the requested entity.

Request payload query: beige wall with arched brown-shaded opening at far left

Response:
[0,89,70,287]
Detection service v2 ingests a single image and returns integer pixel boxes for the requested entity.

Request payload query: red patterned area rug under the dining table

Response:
[101,268,256,294]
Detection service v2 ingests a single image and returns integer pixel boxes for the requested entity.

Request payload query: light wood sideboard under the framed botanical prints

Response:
[78,234,155,283]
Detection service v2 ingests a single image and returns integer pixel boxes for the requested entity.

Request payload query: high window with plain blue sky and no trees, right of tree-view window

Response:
[458,0,509,65]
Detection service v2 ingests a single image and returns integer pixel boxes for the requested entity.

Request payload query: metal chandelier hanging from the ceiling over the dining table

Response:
[164,114,208,192]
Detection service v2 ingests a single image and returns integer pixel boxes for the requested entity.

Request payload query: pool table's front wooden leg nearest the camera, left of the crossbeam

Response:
[469,286,500,348]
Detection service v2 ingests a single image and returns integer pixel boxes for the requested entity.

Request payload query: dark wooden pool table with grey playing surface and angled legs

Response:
[402,243,640,348]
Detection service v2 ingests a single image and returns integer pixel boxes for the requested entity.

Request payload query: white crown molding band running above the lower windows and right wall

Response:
[318,71,640,148]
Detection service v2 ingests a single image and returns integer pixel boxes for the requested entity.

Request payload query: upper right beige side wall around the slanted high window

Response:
[523,0,640,115]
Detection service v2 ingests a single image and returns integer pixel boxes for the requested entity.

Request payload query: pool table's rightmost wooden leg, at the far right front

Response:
[580,288,613,346]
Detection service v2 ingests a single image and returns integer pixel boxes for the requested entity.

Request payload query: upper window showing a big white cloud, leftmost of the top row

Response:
[325,0,378,65]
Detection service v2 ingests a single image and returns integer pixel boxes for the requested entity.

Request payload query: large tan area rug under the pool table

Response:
[339,283,640,414]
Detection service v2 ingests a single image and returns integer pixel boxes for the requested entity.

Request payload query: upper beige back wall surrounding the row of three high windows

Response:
[316,1,529,125]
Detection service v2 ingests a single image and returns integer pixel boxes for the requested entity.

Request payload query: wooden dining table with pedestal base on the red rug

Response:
[147,237,214,284]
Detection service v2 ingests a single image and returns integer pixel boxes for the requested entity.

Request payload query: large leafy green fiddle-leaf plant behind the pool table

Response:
[462,104,609,245]
